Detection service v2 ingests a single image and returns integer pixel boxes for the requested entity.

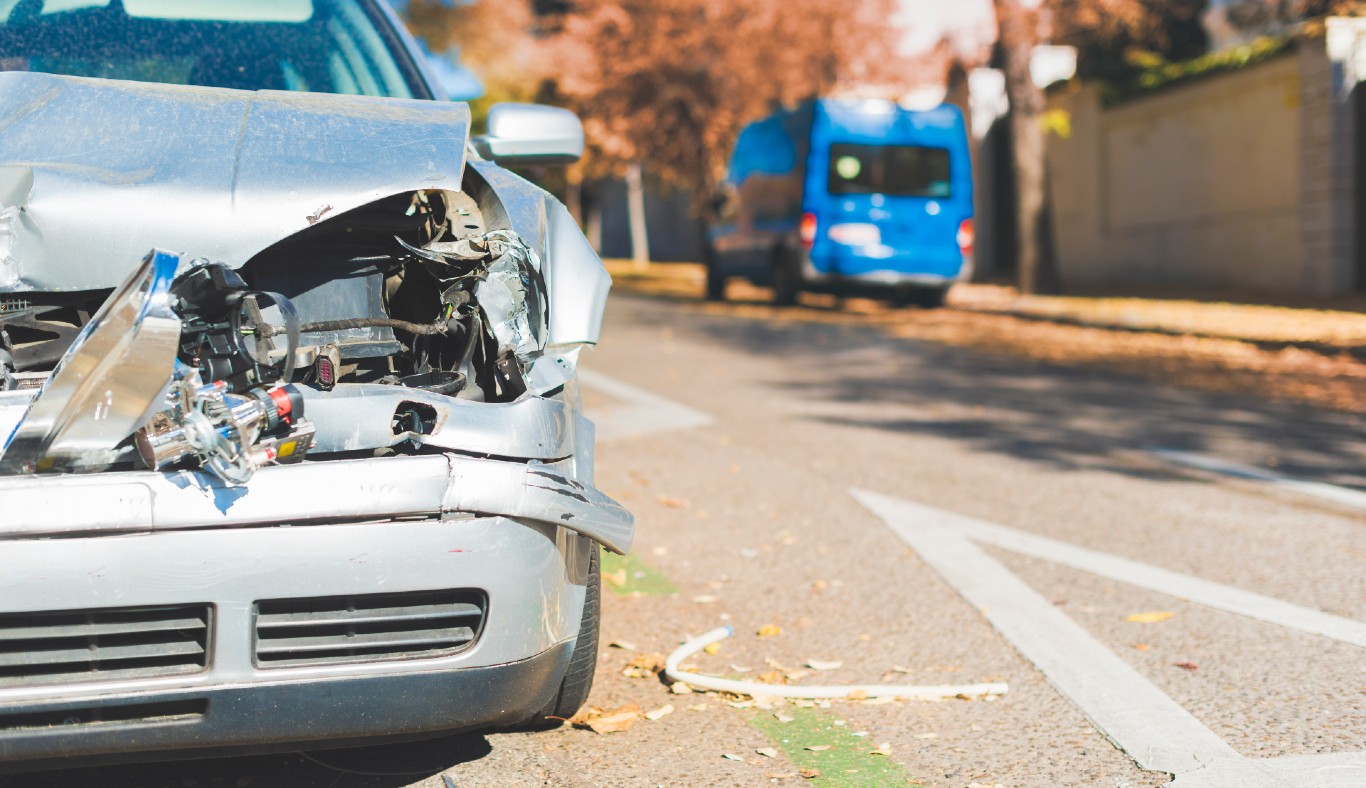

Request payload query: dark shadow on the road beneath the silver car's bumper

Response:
[8,733,492,788]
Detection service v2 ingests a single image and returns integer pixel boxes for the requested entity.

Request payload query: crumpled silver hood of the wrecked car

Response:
[0,72,470,292]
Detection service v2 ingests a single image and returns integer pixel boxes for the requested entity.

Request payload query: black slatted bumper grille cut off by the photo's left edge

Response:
[0,605,210,687]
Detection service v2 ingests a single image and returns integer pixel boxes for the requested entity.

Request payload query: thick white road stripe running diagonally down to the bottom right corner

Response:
[850,489,1366,788]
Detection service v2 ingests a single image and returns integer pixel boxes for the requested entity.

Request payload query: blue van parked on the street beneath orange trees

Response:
[706,98,974,307]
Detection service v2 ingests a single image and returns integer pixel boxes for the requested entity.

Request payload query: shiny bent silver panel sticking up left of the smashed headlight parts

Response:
[0,251,180,474]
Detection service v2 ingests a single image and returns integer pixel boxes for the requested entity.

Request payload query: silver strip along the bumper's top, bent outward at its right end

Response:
[0,455,634,553]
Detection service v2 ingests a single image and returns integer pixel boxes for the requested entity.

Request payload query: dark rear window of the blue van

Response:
[829,142,953,199]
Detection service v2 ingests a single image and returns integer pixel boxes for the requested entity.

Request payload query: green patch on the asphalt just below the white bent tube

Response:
[750,706,918,787]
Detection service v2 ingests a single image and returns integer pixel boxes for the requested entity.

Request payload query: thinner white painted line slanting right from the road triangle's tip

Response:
[926,509,1366,647]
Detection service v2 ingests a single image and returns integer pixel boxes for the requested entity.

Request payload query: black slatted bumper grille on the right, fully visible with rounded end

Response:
[255,590,488,668]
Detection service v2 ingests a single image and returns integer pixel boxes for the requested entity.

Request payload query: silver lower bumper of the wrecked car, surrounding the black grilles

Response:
[0,513,597,762]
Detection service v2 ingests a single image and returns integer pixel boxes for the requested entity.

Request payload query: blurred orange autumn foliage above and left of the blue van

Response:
[407,0,908,210]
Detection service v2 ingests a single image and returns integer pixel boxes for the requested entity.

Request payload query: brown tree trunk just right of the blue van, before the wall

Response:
[996,0,1061,292]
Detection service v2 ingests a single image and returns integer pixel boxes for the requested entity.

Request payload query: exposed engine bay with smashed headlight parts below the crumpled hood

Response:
[0,176,562,485]
